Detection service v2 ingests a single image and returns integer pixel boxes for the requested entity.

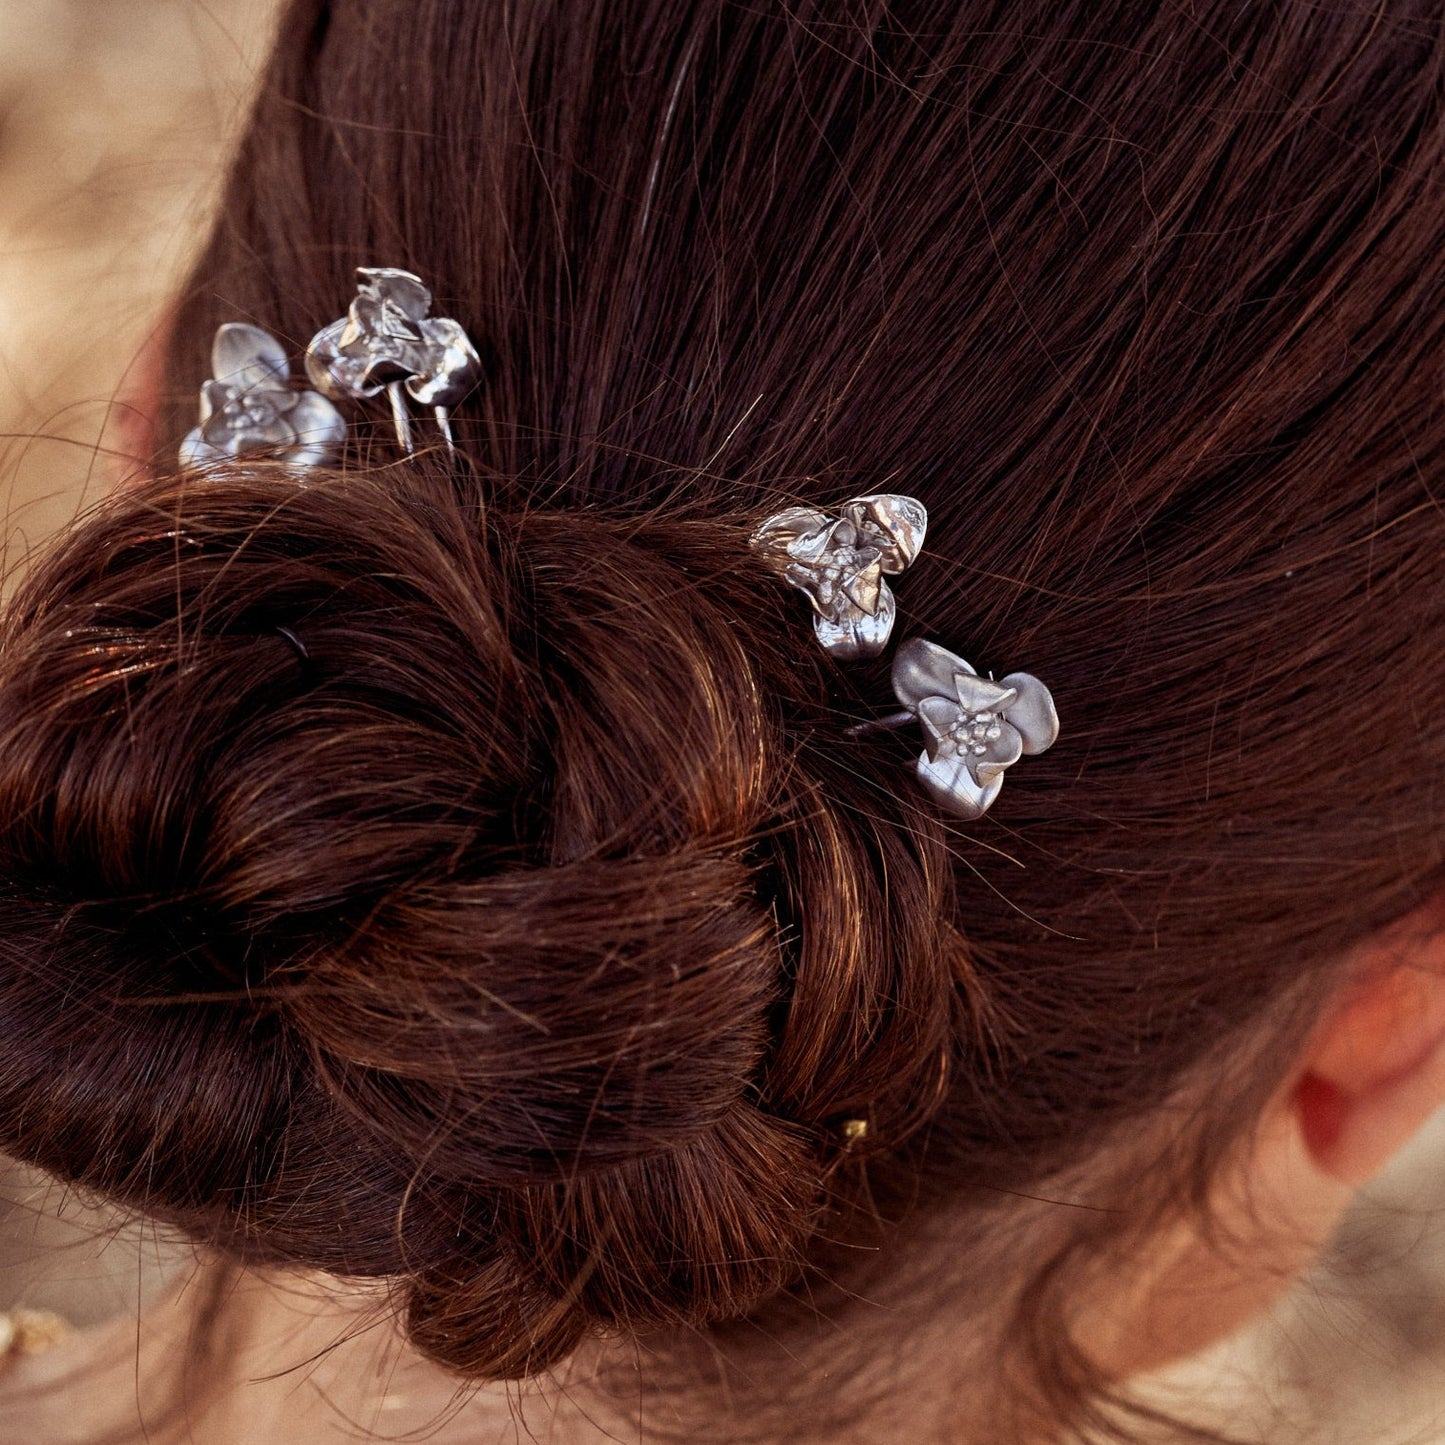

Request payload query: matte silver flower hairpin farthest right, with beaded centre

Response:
[893,637,1059,818]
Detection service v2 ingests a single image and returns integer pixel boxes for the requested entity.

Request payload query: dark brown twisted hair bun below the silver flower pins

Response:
[0,465,951,1374]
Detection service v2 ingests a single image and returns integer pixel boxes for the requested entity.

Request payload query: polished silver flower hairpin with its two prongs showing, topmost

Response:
[306,266,481,452]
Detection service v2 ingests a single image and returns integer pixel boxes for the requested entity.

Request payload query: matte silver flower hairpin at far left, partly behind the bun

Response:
[181,321,347,471]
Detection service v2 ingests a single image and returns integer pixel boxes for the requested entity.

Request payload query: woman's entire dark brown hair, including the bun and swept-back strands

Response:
[0,0,1445,1438]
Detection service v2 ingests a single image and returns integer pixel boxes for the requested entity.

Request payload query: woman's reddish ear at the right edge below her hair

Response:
[1293,900,1445,1185]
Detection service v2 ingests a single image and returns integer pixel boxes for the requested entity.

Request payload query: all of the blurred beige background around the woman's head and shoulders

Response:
[0,0,1445,1445]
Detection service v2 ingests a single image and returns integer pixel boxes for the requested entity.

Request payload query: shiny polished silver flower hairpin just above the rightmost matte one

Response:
[751,493,928,659]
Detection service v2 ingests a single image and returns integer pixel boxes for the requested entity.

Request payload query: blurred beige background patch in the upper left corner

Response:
[0,0,275,564]
